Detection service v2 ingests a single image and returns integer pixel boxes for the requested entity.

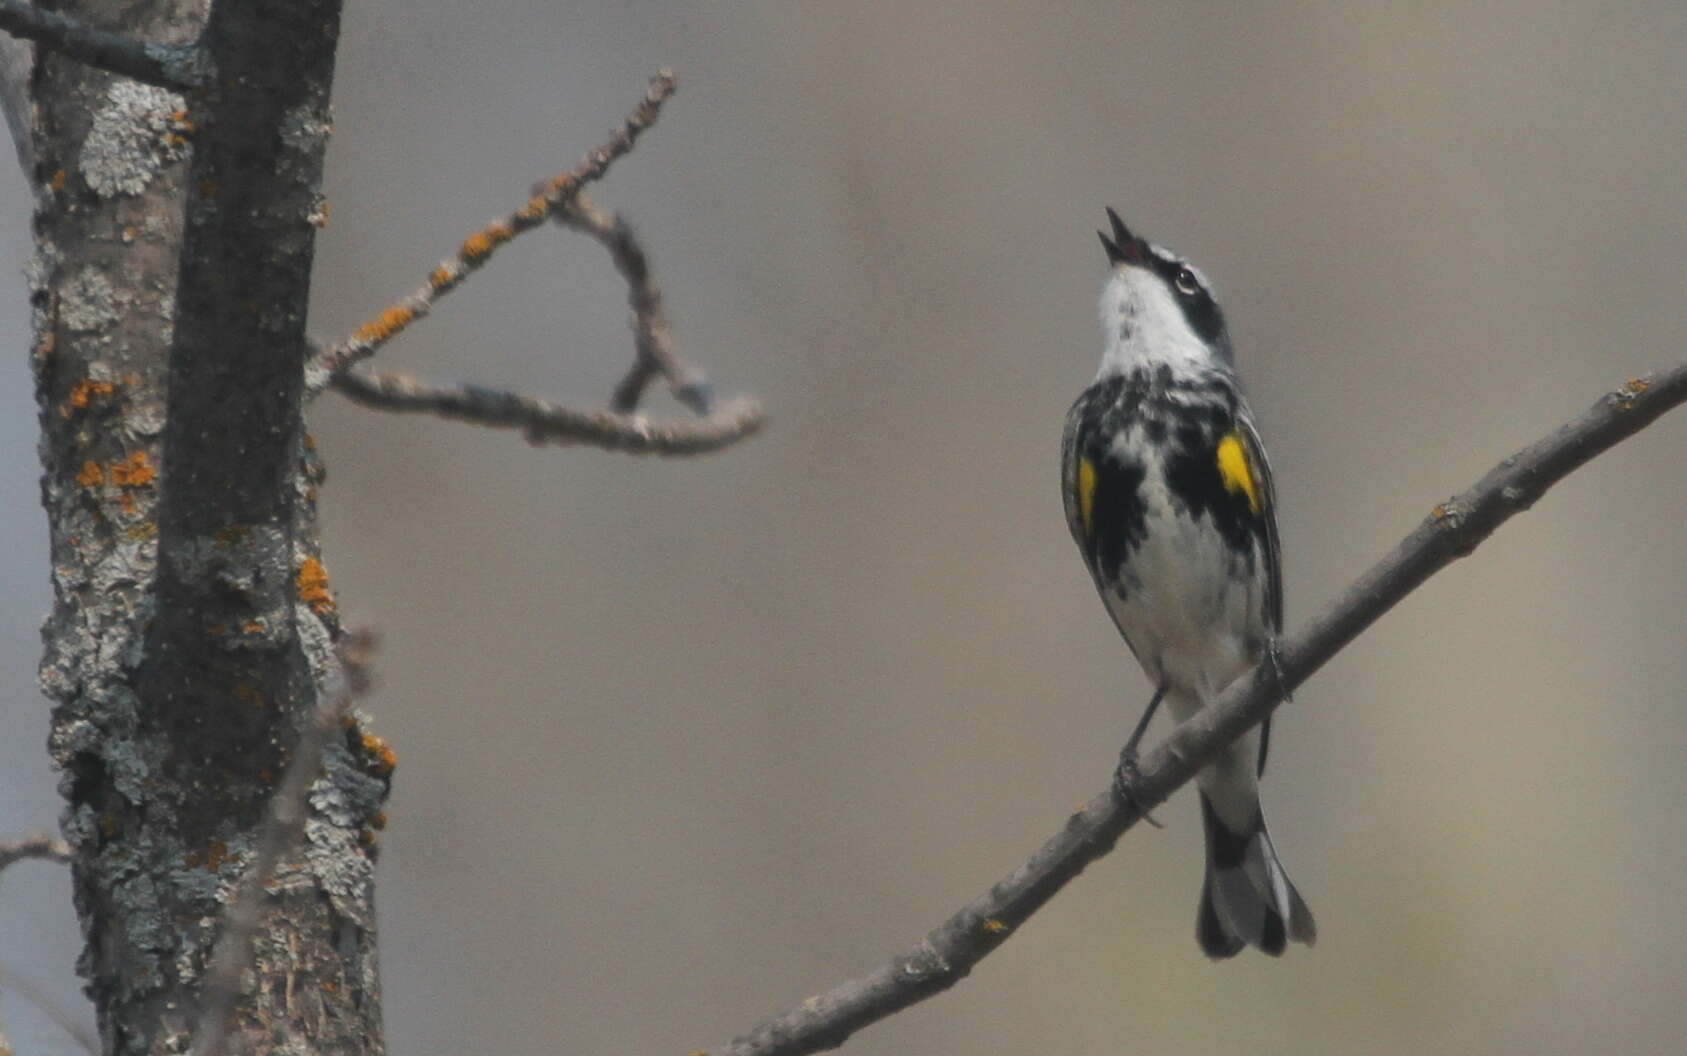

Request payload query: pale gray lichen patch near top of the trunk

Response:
[78,79,187,197]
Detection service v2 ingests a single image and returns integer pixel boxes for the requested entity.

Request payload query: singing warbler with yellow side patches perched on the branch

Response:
[1061,209,1318,958]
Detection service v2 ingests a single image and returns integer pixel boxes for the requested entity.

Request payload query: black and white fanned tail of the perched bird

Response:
[1194,789,1318,960]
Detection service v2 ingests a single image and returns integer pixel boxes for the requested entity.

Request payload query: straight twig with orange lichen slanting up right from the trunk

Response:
[305,69,678,398]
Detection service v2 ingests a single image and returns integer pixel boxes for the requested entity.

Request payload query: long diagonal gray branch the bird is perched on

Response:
[717,363,1687,1056]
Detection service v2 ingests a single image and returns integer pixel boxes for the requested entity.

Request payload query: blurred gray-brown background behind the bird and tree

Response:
[0,0,1687,1056]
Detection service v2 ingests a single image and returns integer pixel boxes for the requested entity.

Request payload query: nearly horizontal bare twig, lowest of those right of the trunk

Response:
[334,368,766,455]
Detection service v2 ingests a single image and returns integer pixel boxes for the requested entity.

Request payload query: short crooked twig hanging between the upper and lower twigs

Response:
[557,194,714,415]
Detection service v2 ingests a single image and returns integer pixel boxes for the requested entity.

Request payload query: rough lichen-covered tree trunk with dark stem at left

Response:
[30,0,382,1054]
